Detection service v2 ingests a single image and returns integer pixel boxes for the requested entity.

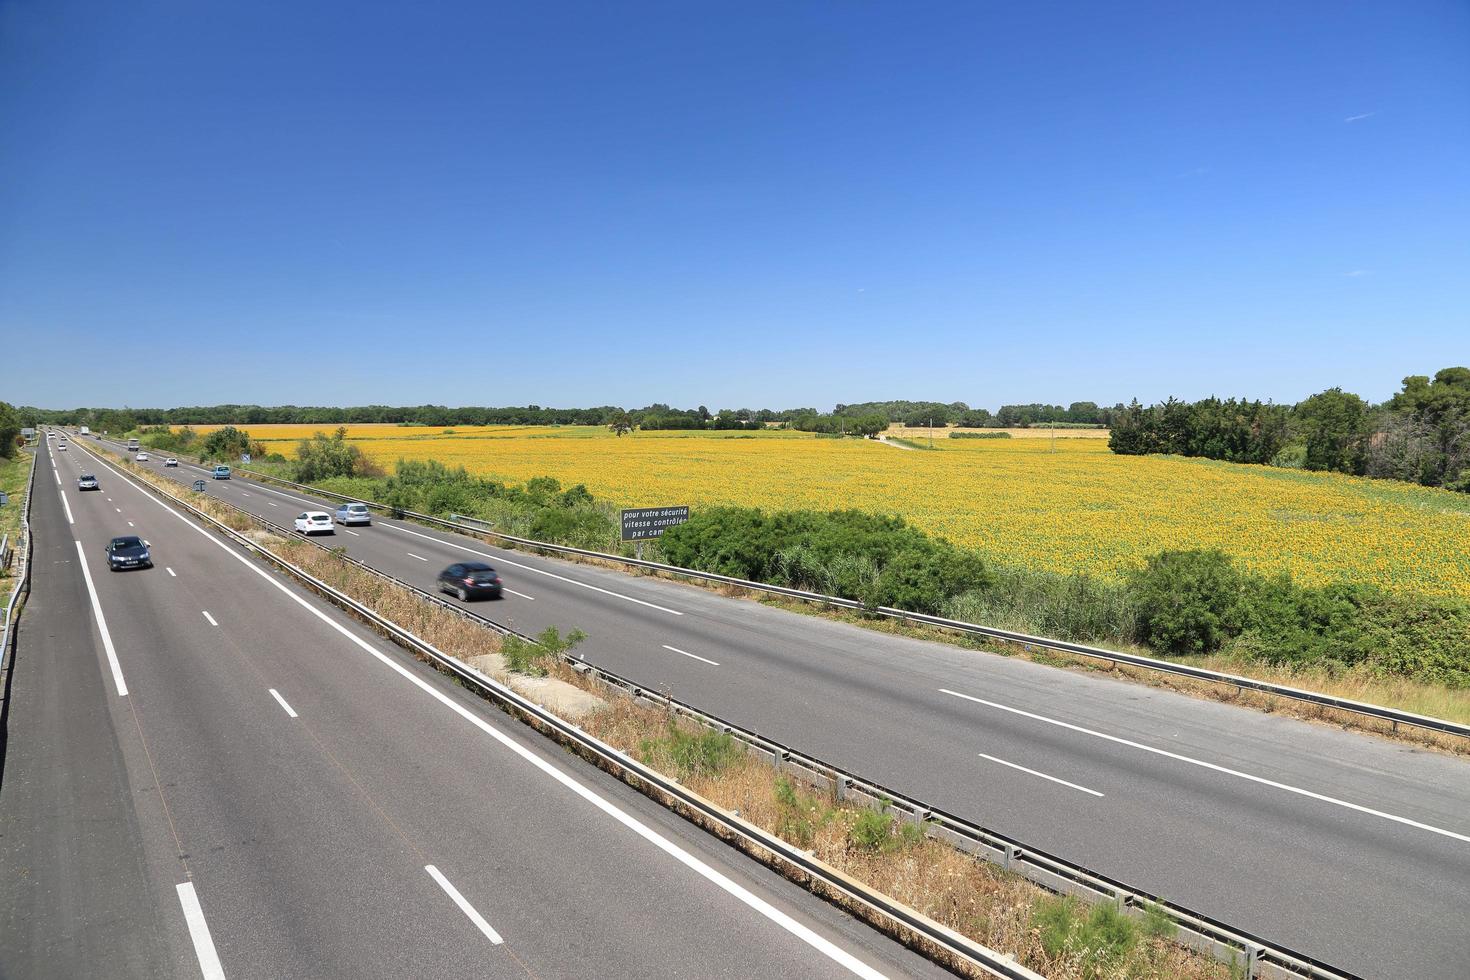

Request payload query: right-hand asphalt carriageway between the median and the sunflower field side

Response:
[77,434,1470,980]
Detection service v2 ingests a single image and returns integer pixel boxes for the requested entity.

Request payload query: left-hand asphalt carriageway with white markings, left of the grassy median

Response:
[0,445,942,977]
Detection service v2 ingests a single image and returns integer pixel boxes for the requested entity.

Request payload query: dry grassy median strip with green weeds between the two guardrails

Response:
[103,443,1230,980]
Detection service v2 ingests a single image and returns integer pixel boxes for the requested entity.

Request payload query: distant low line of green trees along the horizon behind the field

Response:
[19,401,1123,432]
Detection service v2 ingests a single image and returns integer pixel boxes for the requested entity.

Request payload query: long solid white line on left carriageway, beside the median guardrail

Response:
[78,443,886,980]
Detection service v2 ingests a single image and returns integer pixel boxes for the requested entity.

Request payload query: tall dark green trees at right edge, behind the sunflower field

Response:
[1108,367,1470,492]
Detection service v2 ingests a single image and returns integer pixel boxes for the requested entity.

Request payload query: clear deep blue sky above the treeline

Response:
[0,0,1470,408]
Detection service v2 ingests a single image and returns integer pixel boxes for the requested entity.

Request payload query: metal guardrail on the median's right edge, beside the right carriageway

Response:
[74,437,1355,980]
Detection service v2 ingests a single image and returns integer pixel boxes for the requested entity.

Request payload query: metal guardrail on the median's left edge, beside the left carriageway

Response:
[69,437,1044,980]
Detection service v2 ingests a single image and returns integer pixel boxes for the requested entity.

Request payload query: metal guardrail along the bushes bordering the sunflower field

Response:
[94,431,1470,738]
